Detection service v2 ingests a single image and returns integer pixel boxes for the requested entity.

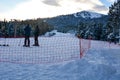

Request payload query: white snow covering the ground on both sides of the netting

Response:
[0,31,120,80]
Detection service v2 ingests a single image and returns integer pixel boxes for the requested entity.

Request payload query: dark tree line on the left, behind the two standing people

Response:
[0,18,53,37]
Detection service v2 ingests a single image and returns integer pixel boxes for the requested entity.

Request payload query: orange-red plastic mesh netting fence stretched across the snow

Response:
[0,36,89,64]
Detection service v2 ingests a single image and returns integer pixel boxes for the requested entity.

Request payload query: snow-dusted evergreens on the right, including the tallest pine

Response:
[77,0,120,43]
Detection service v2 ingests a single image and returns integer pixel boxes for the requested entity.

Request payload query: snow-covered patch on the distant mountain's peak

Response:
[74,11,103,19]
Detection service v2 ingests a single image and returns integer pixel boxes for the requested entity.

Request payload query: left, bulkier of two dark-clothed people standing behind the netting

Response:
[23,24,31,47]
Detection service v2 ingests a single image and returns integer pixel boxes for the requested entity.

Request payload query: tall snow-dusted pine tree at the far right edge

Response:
[108,0,120,42]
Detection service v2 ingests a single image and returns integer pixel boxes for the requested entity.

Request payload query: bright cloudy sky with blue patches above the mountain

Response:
[0,0,115,20]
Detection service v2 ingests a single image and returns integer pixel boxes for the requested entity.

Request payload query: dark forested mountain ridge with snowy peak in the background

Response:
[44,11,108,32]
